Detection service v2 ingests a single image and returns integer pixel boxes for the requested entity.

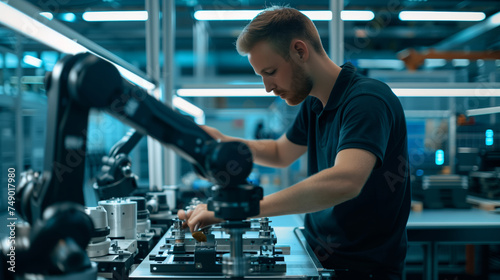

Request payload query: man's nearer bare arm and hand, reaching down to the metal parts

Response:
[179,149,376,231]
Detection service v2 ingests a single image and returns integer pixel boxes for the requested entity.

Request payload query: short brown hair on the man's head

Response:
[236,6,325,60]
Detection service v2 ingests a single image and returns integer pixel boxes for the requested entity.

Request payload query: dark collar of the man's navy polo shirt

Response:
[312,62,356,115]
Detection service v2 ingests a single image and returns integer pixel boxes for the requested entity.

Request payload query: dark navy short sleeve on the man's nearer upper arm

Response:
[337,95,393,168]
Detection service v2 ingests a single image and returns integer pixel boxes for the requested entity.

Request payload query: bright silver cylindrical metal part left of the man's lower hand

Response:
[99,198,137,239]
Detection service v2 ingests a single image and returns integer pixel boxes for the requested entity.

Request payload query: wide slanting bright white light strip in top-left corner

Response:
[0,1,88,54]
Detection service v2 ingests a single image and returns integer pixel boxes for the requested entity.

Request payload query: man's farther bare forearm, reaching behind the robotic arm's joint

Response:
[202,126,307,168]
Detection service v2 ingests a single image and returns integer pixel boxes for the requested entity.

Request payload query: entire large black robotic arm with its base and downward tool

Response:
[1,53,262,279]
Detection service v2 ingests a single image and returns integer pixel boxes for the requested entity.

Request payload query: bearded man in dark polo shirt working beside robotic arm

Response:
[179,4,411,279]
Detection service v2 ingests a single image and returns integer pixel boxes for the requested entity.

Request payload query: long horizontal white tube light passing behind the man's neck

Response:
[177,88,500,97]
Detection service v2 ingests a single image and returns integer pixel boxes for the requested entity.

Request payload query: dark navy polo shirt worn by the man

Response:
[286,63,411,274]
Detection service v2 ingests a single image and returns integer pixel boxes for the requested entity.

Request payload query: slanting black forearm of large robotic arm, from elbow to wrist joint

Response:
[68,54,252,187]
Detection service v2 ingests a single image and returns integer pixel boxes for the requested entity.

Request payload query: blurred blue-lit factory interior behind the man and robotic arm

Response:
[0,0,500,279]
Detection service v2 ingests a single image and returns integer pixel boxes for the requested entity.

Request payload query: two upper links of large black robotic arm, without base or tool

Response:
[22,53,253,221]
